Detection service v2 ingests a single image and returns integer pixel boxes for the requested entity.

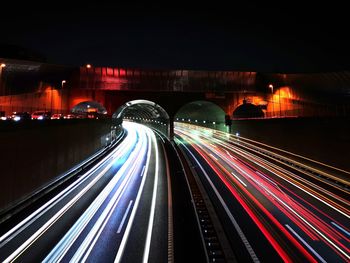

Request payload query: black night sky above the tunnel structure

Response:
[0,0,350,72]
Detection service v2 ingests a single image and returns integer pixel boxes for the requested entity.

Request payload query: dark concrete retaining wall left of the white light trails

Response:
[0,119,111,210]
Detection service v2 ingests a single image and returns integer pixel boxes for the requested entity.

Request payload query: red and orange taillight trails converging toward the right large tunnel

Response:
[175,125,350,261]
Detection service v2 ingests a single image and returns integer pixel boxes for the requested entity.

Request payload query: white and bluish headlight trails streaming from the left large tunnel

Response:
[0,123,164,262]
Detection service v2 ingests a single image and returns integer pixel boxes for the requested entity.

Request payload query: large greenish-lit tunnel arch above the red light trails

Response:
[174,100,225,124]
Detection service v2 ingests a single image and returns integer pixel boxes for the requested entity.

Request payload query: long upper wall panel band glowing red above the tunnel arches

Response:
[79,67,256,92]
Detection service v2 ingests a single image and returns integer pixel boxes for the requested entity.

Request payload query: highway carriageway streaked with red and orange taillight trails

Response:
[175,123,350,262]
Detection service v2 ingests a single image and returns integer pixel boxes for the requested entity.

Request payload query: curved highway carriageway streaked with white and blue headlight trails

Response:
[0,122,172,262]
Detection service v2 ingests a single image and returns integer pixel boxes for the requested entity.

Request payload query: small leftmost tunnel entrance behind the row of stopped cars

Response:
[71,101,107,118]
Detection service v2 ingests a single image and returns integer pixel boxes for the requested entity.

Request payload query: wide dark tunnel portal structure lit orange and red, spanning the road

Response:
[0,59,350,136]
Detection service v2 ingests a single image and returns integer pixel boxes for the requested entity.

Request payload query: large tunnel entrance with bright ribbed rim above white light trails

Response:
[112,100,170,137]
